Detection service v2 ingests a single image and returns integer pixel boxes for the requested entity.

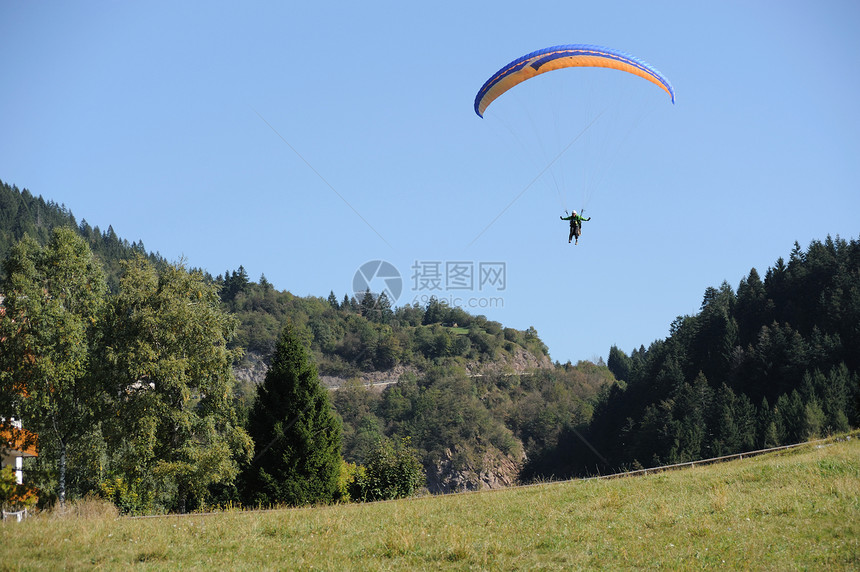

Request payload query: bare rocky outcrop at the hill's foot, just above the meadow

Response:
[427,446,525,494]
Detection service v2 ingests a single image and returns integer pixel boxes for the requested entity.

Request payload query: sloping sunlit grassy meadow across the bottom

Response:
[0,437,860,570]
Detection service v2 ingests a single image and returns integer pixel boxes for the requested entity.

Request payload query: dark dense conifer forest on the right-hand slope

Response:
[526,233,860,478]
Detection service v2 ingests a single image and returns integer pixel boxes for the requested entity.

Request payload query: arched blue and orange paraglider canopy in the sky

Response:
[475,44,675,117]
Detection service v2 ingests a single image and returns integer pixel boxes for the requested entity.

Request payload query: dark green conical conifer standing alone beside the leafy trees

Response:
[245,325,341,505]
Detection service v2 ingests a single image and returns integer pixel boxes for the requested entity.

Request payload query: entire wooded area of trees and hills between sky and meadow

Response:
[0,182,860,512]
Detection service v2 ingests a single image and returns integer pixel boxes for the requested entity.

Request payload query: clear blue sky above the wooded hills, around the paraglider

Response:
[0,1,860,362]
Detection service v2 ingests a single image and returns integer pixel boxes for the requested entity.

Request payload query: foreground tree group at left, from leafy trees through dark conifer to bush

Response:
[0,227,430,512]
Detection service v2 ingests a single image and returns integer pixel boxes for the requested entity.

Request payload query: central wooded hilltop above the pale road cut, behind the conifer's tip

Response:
[214,266,549,377]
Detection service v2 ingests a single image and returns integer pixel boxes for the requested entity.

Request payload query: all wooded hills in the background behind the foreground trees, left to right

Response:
[0,179,860,502]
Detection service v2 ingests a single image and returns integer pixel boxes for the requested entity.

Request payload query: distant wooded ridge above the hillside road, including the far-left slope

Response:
[0,180,552,384]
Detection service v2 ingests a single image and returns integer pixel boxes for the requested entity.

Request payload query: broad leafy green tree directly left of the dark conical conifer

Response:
[102,257,251,511]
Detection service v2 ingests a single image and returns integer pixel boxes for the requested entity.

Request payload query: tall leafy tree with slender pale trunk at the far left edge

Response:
[0,228,106,502]
